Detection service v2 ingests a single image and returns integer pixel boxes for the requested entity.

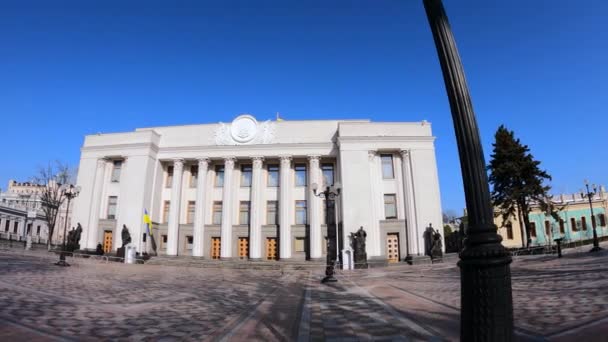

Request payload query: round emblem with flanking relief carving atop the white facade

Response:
[213,114,276,145]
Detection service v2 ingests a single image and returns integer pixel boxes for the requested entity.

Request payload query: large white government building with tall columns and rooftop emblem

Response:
[72,114,442,261]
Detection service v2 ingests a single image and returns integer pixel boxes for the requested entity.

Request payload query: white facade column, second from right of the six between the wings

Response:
[279,156,294,259]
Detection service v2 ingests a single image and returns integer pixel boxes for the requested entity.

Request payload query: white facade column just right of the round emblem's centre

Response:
[249,157,264,260]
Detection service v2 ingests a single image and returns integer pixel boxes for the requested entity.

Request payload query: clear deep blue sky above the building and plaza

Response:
[0,0,608,212]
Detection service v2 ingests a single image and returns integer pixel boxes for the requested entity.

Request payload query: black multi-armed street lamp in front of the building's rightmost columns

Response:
[312,183,341,283]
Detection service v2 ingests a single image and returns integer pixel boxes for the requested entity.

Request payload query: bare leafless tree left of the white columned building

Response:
[33,161,74,250]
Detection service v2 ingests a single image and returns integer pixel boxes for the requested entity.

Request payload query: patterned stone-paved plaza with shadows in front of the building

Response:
[0,244,608,342]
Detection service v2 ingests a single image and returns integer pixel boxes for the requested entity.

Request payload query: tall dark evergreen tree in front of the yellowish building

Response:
[488,125,551,246]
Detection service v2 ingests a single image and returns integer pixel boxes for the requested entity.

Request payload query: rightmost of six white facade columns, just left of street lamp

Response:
[307,155,323,259]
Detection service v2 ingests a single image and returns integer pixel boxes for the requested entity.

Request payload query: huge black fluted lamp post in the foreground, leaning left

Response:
[423,0,513,341]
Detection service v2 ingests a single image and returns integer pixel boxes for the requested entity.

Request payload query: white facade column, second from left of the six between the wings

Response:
[192,157,209,257]
